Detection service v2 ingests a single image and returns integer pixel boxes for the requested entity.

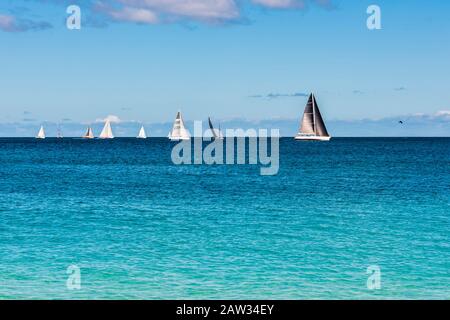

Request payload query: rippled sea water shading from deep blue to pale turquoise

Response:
[0,138,450,299]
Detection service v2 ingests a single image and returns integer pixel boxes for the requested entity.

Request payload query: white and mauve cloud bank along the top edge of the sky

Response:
[0,0,333,32]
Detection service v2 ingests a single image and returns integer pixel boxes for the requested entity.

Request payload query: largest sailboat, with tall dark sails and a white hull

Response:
[295,93,331,141]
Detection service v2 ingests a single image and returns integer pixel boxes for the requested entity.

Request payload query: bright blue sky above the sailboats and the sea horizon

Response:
[0,0,450,135]
